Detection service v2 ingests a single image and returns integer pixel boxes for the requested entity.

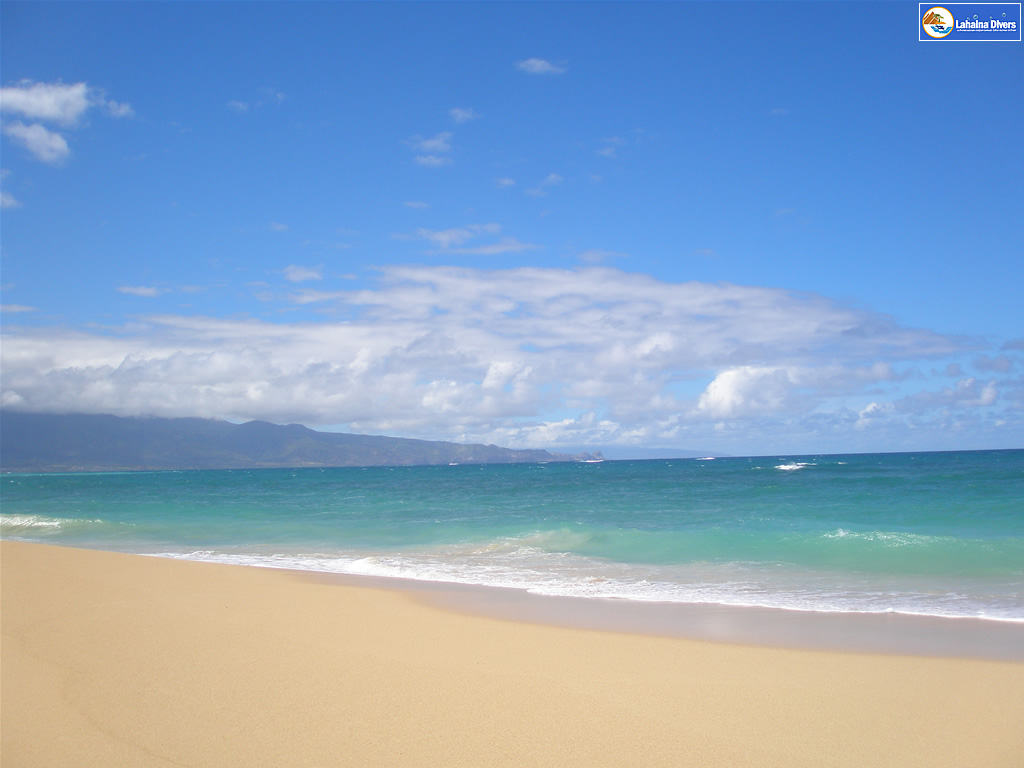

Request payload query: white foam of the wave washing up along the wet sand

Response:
[149,544,1024,623]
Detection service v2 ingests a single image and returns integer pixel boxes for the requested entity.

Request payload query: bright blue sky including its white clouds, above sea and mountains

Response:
[0,0,1024,456]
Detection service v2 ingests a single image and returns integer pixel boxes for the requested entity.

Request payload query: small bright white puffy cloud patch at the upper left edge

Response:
[0,80,135,165]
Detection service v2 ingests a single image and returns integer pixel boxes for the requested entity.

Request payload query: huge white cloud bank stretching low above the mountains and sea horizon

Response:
[0,268,998,453]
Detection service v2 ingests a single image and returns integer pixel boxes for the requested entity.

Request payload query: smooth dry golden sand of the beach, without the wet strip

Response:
[0,542,1024,768]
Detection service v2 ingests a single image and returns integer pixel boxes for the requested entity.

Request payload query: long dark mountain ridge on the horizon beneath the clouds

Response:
[0,411,603,472]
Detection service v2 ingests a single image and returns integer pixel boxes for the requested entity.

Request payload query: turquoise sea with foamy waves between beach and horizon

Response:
[0,451,1024,622]
